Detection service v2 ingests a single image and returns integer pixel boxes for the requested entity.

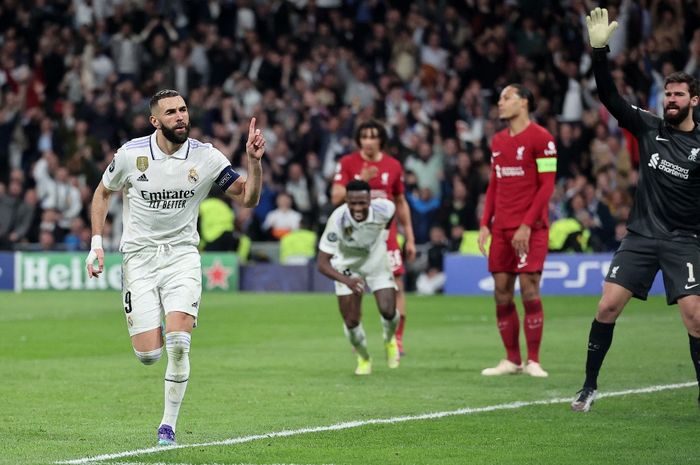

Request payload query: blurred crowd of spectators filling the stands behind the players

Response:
[0,0,700,280]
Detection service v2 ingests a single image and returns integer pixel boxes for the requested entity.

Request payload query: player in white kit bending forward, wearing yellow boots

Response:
[318,179,400,375]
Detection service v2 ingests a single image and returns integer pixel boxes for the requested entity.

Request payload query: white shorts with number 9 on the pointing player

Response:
[122,245,202,336]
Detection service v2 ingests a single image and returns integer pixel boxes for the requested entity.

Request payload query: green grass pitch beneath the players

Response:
[0,292,700,465]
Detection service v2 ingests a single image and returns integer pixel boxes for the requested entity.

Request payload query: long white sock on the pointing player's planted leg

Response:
[160,331,192,431]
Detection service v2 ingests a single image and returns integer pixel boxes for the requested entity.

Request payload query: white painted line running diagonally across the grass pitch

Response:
[54,381,698,465]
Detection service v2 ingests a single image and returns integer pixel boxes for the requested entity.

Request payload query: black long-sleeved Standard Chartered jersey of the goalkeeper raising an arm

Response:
[593,49,700,241]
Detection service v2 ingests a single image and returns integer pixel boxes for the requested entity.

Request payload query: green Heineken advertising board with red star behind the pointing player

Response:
[16,252,238,291]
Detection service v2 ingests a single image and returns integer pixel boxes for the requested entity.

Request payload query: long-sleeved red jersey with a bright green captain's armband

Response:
[481,123,557,229]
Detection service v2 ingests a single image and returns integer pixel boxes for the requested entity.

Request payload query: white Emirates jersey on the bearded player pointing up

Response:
[102,132,238,252]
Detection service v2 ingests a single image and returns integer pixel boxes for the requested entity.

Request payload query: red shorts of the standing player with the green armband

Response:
[489,228,549,273]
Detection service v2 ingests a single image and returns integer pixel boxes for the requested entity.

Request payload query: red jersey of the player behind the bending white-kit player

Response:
[333,152,404,201]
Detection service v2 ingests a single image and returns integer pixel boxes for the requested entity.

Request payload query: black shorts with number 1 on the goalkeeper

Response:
[605,232,700,305]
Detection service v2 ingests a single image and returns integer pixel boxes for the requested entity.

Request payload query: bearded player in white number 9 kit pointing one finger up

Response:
[86,90,265,445]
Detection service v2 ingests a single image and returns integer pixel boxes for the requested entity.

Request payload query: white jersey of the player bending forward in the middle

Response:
[318,199,396,271]
